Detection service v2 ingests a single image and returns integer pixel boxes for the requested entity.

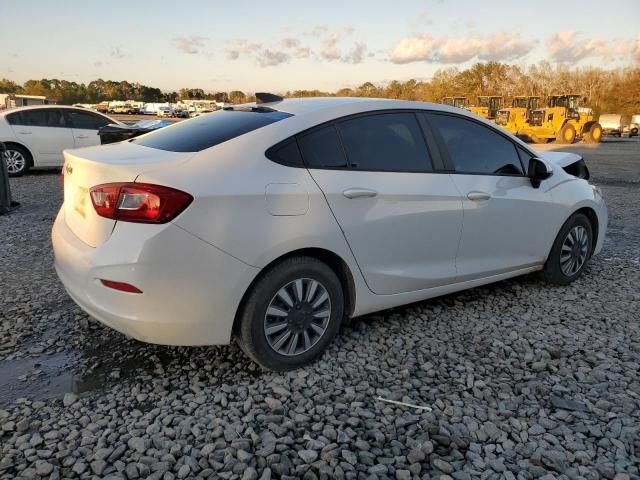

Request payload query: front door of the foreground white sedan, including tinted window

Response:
[425,113,562,281]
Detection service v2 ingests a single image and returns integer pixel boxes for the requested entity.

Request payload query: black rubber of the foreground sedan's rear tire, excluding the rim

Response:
[237,256,344,371]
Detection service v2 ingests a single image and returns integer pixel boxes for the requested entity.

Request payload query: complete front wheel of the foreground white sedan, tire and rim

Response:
[542,213,593,285]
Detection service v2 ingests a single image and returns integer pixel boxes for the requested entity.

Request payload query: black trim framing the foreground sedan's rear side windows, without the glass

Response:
[265,108,451,174]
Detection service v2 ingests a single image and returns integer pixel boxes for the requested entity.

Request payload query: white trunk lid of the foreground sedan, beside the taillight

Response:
[62,142,193,247]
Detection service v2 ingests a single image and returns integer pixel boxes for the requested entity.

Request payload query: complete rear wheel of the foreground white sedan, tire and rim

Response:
[237,257,344,371]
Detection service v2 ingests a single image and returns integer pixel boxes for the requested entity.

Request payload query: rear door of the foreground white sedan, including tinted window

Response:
[298,111,462,294]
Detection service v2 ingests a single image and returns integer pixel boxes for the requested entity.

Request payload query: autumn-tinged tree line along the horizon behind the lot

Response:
[0,61,640,114]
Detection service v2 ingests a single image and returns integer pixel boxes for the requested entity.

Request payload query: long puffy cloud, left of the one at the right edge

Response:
[391,32,536,63]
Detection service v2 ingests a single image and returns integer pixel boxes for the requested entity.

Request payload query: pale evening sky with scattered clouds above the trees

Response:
[0,0,640,92]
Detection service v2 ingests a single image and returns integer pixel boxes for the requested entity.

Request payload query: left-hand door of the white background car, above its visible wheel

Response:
[9,108,74,167]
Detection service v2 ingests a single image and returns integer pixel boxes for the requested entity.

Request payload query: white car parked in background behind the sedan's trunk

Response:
[0,105,120,176]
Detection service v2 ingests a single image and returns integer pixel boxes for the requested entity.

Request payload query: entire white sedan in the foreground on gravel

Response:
[53,94,607,370]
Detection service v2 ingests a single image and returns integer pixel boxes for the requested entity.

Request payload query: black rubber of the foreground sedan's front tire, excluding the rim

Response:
[542,213,593,285]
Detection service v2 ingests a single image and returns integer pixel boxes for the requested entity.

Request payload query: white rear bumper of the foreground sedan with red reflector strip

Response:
[52,210,258,345]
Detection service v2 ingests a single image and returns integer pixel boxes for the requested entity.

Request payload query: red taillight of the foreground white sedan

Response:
[89,183,193,223]
